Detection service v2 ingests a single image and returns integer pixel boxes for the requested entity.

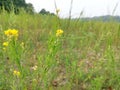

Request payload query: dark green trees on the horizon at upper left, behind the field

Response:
[0,0,55,15]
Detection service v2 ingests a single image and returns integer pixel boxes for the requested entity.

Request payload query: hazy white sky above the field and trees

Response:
[26,0,120,17]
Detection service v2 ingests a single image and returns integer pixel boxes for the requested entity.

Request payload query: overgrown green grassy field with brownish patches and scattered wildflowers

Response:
[0,12,120,90]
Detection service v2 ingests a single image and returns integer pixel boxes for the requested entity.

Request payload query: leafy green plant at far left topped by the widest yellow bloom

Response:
[3,29,24,71]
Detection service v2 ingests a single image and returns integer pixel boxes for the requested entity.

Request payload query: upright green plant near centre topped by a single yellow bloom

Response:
[40,29,64,86]
